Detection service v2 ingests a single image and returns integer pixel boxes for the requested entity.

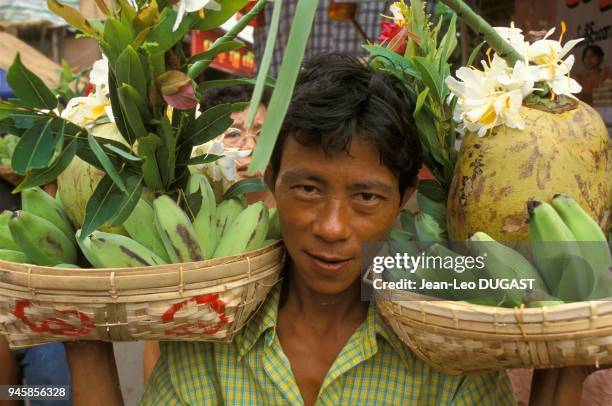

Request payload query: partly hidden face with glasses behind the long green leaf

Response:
[223,105,266,178]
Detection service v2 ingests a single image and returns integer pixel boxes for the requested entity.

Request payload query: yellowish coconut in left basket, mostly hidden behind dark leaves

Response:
[57,123,125,234]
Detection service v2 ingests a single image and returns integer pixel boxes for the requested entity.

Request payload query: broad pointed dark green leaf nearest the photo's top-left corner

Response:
[6,53,57,110]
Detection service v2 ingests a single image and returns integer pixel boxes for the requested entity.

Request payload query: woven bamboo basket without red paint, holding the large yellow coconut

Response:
[376,291,612,374]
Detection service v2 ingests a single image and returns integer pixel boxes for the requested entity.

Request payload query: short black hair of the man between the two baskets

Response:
[270,53,422,196]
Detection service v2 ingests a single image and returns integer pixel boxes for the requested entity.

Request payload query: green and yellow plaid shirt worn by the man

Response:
[140,284,515,406]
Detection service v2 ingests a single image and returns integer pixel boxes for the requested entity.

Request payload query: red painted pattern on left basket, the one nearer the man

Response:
[162,293,229,336]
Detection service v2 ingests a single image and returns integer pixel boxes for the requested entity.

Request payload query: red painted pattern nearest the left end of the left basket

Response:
[13,299,94,336]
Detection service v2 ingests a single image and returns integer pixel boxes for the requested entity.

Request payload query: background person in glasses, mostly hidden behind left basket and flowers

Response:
[143,85,274,384]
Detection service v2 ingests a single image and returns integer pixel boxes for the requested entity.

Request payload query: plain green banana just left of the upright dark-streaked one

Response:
[123,198,170,262]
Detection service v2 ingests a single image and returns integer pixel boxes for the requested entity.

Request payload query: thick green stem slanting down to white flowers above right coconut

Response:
[442,0,523,66]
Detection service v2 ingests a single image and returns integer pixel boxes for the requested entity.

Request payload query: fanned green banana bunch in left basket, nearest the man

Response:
[75,174,280,268]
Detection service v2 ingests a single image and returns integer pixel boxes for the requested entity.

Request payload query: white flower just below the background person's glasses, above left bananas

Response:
[191,140,251,192]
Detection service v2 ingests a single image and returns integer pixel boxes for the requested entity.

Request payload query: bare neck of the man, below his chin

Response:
[279,267,368,334]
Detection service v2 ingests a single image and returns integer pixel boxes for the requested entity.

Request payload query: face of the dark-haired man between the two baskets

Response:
[274,137,408,294]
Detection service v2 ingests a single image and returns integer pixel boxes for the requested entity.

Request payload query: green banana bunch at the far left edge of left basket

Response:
[0,187,78,266]
